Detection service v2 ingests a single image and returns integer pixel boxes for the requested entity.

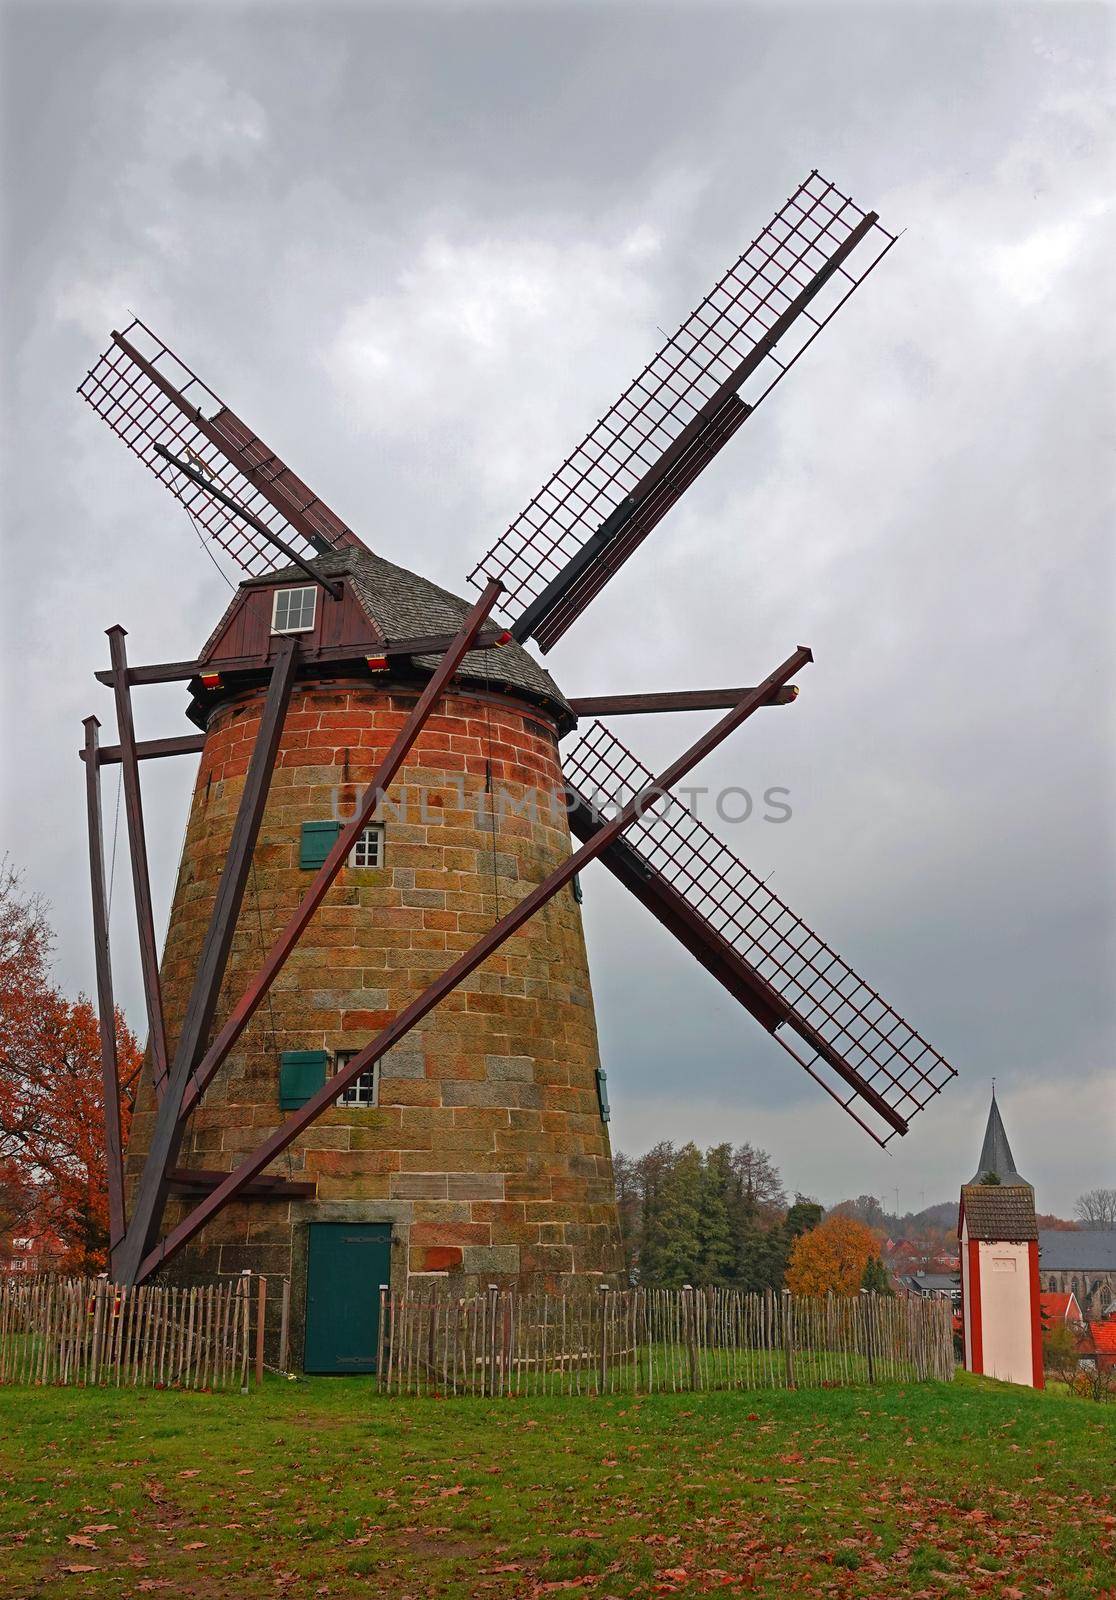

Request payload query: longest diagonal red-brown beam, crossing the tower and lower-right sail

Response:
[136,643,802,1283]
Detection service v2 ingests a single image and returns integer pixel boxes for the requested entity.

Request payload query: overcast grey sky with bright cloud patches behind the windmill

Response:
[3,3,1116,1213]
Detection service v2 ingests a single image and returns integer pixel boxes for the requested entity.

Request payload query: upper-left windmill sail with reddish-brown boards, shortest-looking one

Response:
[78,318,368,578]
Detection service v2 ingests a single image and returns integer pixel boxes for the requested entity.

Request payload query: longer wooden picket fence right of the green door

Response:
[377,1288,955,1395]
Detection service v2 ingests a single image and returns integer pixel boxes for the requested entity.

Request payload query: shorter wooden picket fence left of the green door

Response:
[0,1275,256,1392]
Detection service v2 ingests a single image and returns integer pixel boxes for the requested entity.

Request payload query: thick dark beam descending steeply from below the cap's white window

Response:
[114,638,299,1285]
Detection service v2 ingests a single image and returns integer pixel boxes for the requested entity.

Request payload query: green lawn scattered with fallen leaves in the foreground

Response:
[0,1378,1116,1600]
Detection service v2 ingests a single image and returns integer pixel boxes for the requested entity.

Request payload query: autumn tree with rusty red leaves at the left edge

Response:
[0,861,142,1270]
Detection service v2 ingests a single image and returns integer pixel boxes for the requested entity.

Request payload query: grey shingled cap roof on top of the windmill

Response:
[240,549,574,731]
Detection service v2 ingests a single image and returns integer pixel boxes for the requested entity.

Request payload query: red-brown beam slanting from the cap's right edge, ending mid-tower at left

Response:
[175,582,502,1117]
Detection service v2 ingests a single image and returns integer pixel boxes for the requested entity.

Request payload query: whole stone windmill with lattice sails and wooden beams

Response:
[80,173,953,1370]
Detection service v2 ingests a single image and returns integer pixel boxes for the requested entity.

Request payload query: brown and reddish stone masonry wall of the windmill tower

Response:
[128,682,619,1338]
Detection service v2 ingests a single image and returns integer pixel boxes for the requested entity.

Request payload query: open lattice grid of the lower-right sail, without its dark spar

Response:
[563,722,956,1144]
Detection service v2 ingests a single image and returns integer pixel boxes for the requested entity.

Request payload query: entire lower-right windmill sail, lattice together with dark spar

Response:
[563,723,956,1144]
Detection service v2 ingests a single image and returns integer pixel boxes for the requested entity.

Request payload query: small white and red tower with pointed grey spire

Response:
[958,1090,1044,1389]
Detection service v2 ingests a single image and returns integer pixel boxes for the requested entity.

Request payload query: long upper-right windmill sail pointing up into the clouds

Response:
[470,173,895,651]
